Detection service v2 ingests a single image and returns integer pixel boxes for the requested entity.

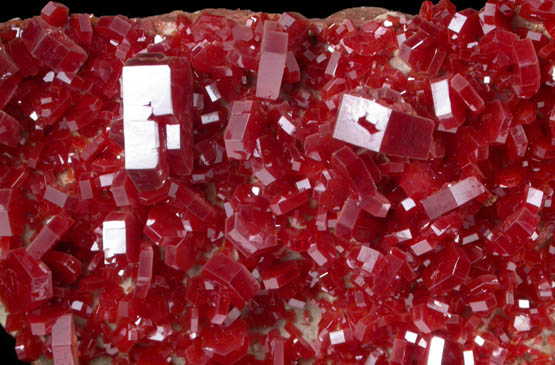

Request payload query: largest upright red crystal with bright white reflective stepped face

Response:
[122,55,193,191]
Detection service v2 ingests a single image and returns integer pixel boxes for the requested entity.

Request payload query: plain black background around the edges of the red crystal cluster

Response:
[0,0,485,365]
